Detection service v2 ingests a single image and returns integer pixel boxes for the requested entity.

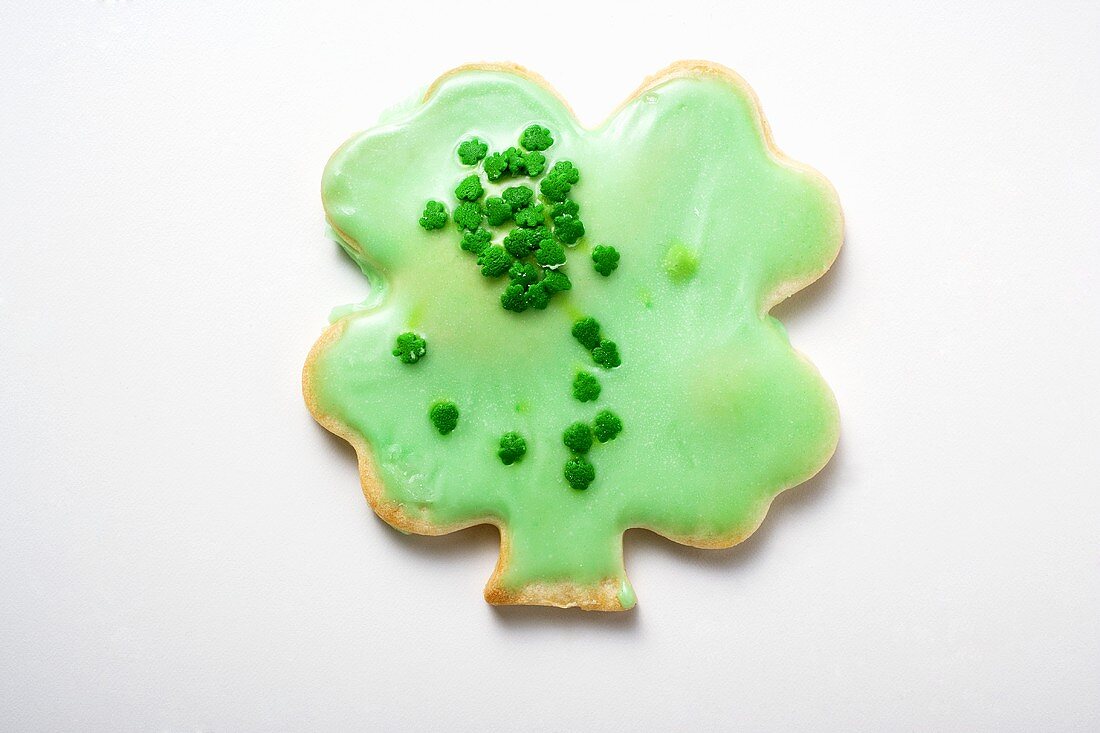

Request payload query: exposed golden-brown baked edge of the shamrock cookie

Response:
[301,61,844,611]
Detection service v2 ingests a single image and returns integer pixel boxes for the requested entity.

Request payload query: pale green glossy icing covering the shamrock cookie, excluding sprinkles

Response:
[307,70,842,608]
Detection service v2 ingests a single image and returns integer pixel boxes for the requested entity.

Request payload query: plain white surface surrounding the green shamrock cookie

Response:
[0,0,1100,731]
